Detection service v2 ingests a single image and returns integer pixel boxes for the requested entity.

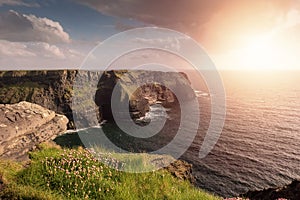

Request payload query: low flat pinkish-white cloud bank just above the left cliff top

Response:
[0,40,84,70]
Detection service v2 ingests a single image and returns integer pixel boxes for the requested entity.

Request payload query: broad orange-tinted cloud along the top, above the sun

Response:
[76,0,299,52]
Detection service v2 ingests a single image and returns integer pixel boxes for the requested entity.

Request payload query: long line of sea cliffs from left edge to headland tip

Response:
[0,70,195,128]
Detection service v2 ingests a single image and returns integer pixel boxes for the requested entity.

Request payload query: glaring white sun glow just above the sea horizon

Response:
[213,31,300,71]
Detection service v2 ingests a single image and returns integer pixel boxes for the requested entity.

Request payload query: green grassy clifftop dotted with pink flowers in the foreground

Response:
[0,145,219,200]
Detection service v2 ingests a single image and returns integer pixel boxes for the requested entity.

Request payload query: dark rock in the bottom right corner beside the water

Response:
[242,180,300,200]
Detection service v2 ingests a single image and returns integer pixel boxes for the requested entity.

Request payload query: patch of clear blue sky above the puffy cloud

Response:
[0,0,137,41]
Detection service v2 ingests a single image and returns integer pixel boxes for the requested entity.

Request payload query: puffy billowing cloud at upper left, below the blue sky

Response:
[0,10,70,44]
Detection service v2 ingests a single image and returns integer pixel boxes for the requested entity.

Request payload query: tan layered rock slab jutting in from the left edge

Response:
[0,101,68,160]
